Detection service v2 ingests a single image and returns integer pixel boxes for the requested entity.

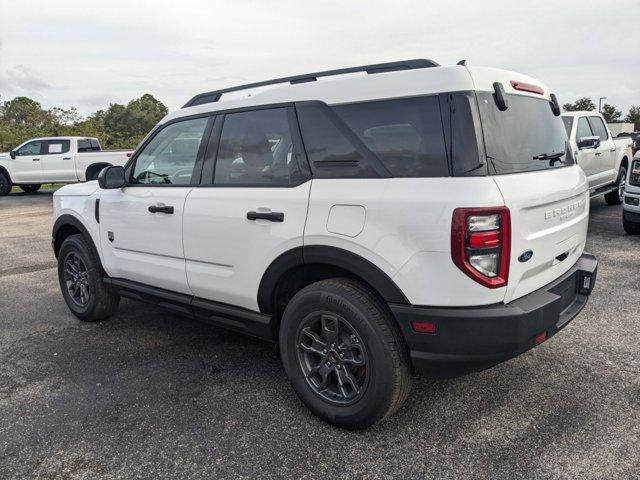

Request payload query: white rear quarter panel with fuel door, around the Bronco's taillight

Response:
[304,177,505,306]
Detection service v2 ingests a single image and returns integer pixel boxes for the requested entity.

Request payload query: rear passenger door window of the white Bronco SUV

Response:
[213,108,302,187]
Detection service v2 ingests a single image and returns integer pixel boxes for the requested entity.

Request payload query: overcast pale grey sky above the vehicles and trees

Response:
[0,0,640,114]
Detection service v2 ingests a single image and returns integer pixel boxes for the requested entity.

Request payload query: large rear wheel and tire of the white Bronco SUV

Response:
[279,278,412,430]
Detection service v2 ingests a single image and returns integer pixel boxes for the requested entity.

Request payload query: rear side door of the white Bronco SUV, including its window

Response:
[184,106,311,310]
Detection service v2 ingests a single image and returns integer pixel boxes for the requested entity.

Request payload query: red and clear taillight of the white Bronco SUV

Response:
[451,207,511,288]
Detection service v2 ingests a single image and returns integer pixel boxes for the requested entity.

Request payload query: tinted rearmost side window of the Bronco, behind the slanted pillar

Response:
[333,96,449,177]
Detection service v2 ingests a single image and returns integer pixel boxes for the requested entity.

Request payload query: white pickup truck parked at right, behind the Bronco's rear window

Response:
[562,111,633,205]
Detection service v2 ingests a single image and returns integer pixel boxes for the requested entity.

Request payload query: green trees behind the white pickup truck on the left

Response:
[0,93,168,152]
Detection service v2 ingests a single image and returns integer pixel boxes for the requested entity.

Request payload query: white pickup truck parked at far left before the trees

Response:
[0,137,132,196]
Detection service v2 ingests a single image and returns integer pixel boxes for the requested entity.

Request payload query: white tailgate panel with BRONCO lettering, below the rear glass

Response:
[492,166,589,303]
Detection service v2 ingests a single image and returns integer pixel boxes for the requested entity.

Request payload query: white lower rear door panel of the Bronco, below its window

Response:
[184,181,311,310]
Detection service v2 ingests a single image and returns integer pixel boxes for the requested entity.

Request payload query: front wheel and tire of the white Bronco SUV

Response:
[58,235,120,322]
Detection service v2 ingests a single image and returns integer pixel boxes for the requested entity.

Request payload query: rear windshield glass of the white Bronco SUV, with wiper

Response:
[477,93,575,175]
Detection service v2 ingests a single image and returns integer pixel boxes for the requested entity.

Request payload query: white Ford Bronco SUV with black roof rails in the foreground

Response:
[53,60,597,428]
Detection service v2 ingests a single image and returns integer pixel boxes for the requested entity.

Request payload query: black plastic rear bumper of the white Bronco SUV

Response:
[389,253,598,373]
